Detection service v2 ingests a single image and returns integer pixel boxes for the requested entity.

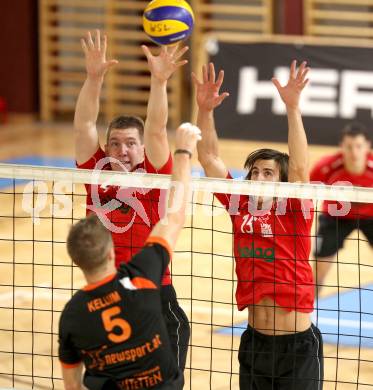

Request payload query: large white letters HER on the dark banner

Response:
[237,66,373,119]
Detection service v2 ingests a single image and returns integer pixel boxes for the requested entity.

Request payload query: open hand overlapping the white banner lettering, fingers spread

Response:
[272,60,310,108]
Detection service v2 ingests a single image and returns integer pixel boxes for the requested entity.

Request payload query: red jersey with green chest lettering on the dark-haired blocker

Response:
[215,175,315,313]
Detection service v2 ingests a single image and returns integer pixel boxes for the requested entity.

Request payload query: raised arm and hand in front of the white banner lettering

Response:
[272,61,310,183]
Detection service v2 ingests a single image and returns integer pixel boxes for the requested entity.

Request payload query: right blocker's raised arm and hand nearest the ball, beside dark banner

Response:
[192,63,229,178]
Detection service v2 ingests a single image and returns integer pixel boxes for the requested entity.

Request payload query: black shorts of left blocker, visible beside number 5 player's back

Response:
[161,285,190,371]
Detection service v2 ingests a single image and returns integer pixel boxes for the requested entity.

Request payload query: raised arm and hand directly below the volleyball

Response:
[142,46,188,169]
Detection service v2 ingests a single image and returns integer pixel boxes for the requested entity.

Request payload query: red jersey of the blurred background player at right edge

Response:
[310,152,373,218]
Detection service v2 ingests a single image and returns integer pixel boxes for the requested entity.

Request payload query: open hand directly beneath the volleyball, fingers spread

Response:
[141,45,189,81]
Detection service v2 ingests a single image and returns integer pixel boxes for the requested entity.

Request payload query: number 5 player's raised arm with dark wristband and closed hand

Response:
[150,123,201,249]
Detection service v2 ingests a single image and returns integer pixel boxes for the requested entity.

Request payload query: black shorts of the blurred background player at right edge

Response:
[314,214,373,258]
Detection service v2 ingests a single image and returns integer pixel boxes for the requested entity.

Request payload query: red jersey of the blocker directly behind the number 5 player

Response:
[77,148,172,285]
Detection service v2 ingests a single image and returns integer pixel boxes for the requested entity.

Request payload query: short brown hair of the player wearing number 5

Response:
[67,214,113,272]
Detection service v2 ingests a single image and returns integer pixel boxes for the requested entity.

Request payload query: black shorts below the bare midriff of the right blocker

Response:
[238,325,324,390]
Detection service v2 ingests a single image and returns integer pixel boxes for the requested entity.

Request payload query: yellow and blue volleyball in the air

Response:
[143,0,194,45]
